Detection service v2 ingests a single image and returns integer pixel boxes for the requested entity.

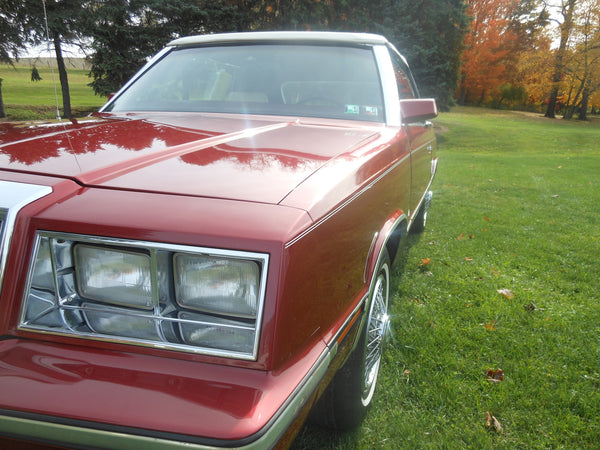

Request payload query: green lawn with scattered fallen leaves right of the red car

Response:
[294,108,600,449]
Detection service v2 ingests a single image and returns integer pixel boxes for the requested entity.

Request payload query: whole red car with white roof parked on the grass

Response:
[0,32,437,449]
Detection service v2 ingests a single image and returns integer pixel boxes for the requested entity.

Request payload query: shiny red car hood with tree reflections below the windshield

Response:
[0,113,377,204]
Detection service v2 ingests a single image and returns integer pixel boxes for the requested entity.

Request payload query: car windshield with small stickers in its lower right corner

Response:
[105,45,384,122]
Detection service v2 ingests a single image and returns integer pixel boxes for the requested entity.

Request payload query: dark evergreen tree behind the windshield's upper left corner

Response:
[85,0,256,95]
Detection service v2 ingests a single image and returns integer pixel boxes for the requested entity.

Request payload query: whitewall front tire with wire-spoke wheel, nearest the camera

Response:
[312,249,391,431]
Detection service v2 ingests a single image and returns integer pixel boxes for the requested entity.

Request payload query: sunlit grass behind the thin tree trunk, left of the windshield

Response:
[0,64,106,120]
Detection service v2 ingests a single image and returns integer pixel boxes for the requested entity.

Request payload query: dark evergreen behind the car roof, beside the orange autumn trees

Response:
[257,0,469,109]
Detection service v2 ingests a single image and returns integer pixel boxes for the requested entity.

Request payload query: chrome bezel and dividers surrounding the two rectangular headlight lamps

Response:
[18,231,269,360]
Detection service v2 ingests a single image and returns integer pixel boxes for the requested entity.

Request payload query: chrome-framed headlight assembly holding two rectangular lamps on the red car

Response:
[19,231,269,359]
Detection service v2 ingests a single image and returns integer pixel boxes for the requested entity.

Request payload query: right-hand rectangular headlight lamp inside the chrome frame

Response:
[175,253,260,319]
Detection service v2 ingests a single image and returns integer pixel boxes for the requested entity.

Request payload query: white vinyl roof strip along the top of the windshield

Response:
[167,31,388,47]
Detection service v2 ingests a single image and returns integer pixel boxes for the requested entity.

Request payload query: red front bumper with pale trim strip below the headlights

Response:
[0,339,335,449]
